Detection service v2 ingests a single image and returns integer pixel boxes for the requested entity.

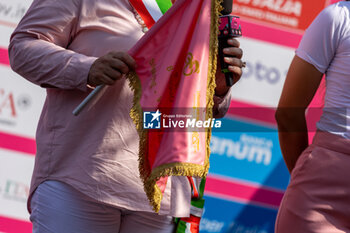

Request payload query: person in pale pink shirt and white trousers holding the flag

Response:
[9,0,243,233]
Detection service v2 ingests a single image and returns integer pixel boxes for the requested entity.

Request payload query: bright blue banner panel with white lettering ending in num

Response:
[209,118,289,190]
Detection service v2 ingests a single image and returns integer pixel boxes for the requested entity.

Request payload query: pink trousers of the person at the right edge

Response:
[275,131,350,233]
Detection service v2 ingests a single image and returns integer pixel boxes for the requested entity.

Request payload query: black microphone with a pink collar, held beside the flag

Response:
[219,0,242,87]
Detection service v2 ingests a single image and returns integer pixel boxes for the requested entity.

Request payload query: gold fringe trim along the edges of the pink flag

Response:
[127,0,222,212]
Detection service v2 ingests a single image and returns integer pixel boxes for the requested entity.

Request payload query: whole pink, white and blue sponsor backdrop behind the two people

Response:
[0,0,336,233]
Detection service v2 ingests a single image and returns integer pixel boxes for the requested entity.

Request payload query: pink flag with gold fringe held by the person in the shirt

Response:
[129,0,220,212]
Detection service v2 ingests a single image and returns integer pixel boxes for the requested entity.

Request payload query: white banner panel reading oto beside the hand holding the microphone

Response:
[232,38,295,107]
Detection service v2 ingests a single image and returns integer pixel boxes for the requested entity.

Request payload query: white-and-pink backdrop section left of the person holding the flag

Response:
[0,0,38,233]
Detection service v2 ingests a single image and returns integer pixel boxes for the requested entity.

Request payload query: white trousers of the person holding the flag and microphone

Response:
[30,181,175,233]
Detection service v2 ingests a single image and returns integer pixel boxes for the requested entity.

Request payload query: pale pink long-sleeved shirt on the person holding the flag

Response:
[9,0,227,216]
